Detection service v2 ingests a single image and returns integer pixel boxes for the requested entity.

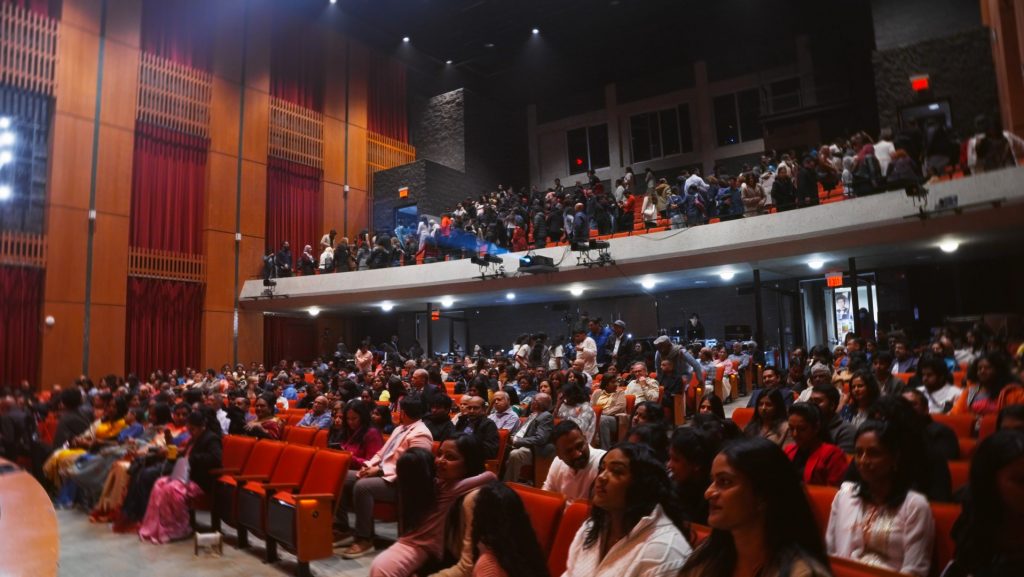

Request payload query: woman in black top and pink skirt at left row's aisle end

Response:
[138,410,221,544]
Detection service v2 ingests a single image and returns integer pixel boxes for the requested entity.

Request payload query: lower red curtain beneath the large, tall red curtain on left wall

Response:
[125,277,204,375]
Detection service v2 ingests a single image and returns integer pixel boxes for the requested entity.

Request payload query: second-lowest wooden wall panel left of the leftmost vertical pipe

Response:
[44,206,89,307]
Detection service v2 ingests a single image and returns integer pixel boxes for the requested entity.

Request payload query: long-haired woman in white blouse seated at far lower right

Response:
[825,420,935,577]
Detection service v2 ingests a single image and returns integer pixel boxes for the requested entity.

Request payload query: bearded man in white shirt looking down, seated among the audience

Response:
[544,419,604,501]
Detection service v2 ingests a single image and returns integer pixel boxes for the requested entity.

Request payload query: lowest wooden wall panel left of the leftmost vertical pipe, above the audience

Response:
[39,303,85,388]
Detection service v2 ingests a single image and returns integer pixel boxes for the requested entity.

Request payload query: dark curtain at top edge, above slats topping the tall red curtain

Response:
[141,0,209,71]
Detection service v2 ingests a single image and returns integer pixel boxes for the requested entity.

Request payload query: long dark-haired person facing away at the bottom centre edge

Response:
[471,483,548,577]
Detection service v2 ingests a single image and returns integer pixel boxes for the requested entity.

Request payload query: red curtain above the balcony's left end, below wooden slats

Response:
[266,157,324,254]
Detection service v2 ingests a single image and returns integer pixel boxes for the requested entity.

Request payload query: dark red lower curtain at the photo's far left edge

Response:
[0,266,43,386]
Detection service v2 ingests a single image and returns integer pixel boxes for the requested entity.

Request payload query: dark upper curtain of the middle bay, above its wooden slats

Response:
[270,17,327,112]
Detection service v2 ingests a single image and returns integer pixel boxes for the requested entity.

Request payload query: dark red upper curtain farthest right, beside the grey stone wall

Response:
[367,52,409,142]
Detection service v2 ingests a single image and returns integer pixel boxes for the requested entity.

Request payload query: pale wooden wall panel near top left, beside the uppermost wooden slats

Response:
[56,20,99,118]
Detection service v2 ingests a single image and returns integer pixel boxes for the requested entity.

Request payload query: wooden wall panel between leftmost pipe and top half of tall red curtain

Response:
[94,125,135,217]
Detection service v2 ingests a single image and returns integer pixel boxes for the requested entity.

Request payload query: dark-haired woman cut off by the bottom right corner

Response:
[942,430,1024,577]
